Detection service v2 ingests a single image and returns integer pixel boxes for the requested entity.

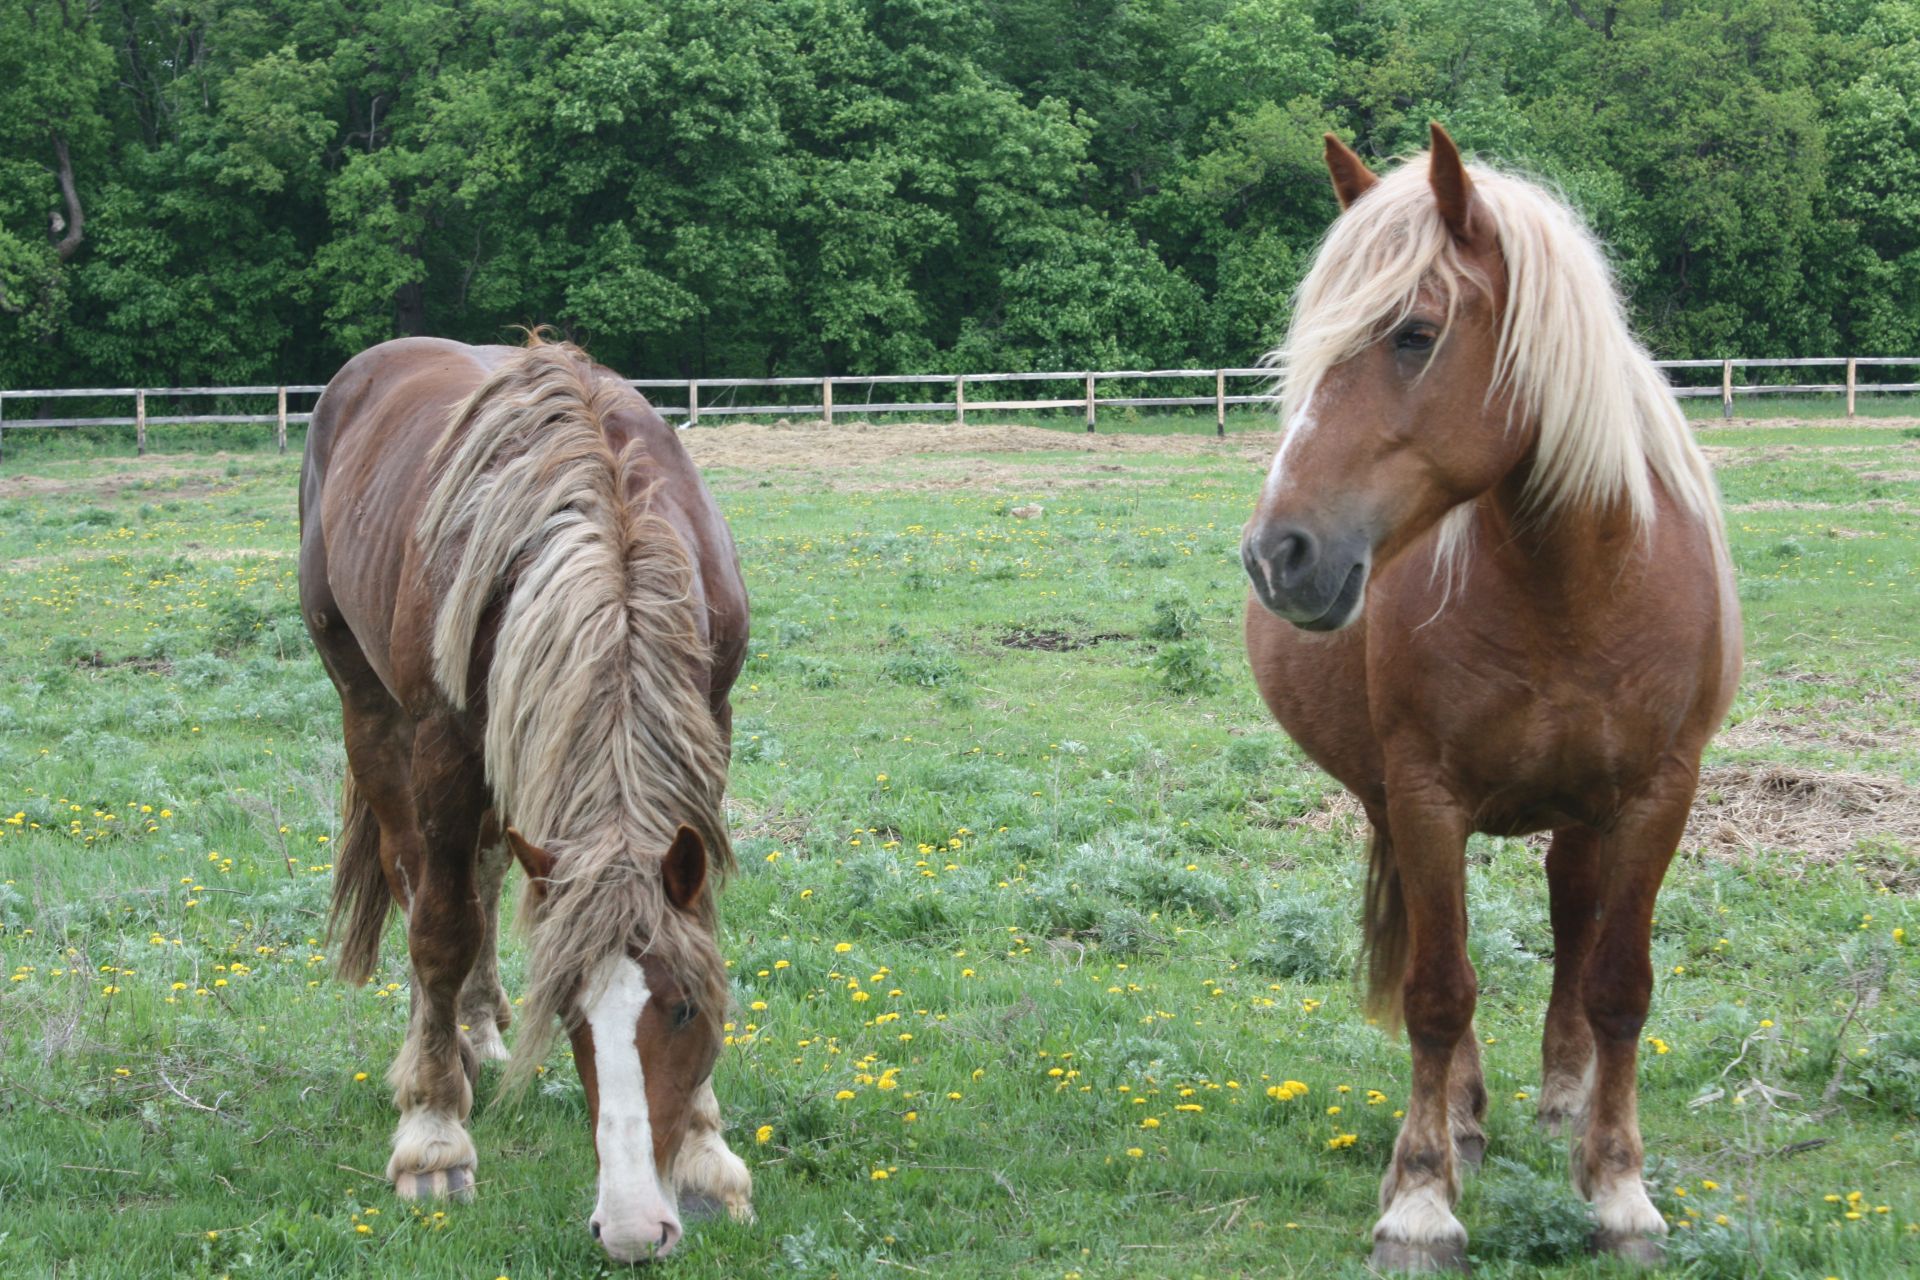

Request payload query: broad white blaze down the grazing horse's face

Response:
[586,956,680,1263]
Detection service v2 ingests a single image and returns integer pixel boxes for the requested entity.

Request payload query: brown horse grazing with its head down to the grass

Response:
[300,336,751,1263]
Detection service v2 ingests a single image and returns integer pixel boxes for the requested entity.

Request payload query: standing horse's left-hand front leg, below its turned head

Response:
[1373,785,1478,1272]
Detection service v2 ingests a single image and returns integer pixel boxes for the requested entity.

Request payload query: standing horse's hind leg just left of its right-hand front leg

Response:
[1536,827,1605,1134]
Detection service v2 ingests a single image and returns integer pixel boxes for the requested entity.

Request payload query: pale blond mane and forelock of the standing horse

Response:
[1271,152,1724,568]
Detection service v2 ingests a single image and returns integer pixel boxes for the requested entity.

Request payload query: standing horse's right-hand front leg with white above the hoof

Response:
[1572,766,1695,1265]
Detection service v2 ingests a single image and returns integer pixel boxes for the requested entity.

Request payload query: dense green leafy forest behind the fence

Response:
[0,0,1920,388]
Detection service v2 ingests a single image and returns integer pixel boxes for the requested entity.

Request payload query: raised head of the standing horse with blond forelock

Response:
[1240,125,1528,631]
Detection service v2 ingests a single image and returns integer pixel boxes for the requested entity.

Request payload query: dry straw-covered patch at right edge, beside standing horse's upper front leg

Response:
[1682,764,1920,890]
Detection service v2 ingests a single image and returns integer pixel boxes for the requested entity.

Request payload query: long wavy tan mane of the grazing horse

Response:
[417,334,733,1080]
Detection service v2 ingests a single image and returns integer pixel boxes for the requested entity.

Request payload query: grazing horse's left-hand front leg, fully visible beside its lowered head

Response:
[386,720,486,1199]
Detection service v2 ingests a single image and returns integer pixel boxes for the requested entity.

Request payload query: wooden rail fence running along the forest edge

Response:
[0,355,1920,459]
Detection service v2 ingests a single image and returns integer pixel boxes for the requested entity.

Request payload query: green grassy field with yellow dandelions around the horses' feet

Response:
[0,422,1920,1280]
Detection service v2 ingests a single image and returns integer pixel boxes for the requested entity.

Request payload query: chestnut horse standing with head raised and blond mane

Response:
[1242,125,1740,1270]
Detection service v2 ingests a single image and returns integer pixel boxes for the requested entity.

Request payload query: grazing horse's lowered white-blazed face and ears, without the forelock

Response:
[507,827,724,1263]
